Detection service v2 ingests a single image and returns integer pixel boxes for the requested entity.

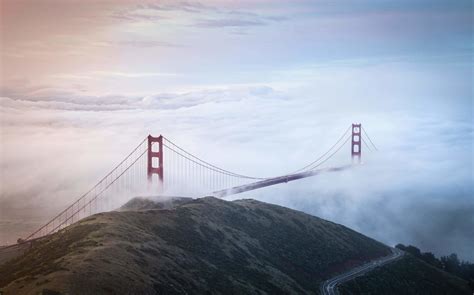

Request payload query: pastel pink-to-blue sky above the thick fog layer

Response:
[2,0,472,100]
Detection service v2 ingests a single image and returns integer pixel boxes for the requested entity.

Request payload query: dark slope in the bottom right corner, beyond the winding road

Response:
[339,254,472,295]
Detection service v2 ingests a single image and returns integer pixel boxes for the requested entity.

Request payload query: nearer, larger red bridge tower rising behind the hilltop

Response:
[147,135,164,188]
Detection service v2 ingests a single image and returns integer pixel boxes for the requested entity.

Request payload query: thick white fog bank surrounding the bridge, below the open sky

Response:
[0,67,474,260]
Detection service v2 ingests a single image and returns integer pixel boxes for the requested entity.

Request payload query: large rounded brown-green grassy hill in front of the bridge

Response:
[0,197,389,294]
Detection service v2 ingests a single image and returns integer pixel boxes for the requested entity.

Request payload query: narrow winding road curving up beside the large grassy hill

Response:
[320,248,403,295]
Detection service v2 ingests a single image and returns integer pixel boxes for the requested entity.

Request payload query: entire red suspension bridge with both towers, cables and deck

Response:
[23,124,377,241]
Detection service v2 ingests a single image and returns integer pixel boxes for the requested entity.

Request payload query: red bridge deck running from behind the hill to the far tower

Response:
[212,165,355,198]
